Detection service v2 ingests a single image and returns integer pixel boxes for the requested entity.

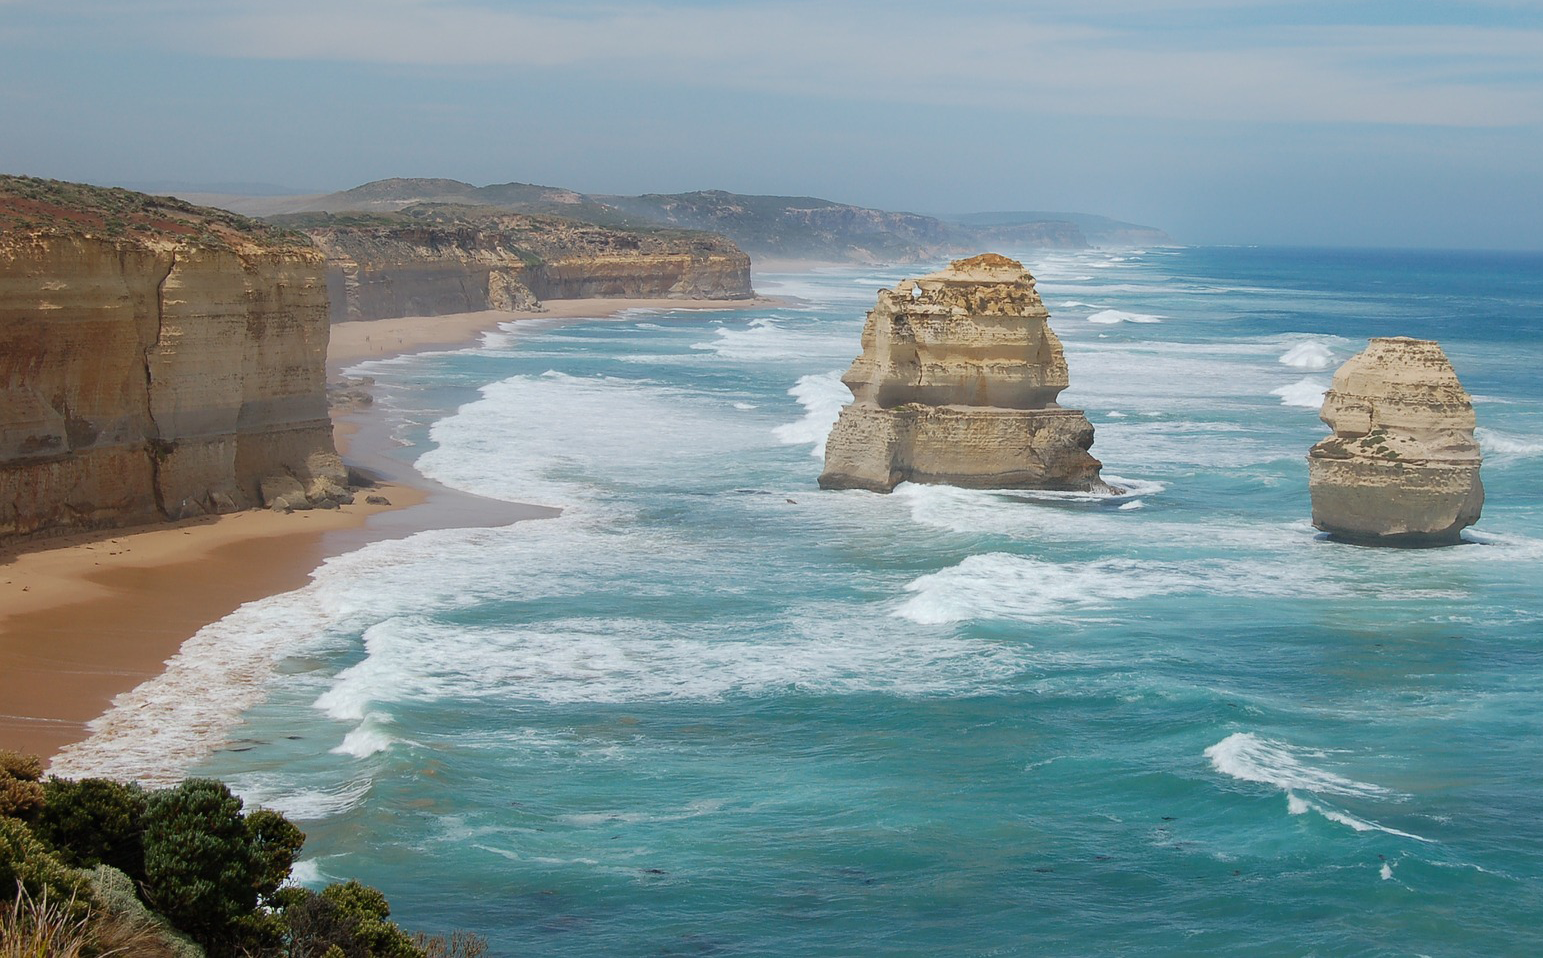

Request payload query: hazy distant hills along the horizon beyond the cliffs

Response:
[192,177,1173,262]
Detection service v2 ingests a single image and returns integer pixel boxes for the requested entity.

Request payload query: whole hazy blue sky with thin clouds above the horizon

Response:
[0,0,1543,248]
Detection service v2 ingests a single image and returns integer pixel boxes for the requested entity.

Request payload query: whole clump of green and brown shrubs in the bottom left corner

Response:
[0,753,488,958]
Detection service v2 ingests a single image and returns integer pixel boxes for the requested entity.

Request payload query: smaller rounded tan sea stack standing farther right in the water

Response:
[1307,336,1484,546]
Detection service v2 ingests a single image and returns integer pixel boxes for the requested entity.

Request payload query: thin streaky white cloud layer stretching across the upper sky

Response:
[66,0,1543,126]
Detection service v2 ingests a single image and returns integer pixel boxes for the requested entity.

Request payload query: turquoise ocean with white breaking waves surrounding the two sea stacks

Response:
[54,248,1543,956]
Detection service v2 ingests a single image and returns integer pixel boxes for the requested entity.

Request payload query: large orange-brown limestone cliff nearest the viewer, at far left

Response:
[0,176,344,538]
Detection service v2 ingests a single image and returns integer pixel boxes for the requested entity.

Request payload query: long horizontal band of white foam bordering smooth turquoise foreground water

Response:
[308,616,1026,707]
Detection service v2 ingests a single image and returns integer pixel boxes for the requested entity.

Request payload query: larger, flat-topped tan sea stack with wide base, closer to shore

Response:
[819,253,1108,492]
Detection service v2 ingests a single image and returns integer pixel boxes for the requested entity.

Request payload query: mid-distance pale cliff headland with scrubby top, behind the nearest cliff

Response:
[287,207,751,321]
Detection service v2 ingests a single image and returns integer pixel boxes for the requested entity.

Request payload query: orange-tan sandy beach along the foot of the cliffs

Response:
[0,291,776,757]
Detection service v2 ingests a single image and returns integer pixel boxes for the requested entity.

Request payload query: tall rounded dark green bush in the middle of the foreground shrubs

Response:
[143,779,258,955]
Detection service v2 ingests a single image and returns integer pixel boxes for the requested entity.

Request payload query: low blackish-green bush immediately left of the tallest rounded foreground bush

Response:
[32,778,148,881]
